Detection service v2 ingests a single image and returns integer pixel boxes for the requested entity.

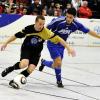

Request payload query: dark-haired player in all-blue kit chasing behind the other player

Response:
[39,8,100,87]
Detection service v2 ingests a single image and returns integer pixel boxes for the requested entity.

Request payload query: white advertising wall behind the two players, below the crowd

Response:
[0,15,100,46]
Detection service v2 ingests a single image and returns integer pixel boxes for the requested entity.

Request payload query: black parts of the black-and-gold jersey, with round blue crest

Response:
[15,25,44,47]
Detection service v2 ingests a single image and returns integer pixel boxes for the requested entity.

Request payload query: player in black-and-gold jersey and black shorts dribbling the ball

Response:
[1,15,73,88]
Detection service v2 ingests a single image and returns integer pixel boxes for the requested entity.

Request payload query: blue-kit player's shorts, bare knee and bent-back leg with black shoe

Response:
[39,45,64,71]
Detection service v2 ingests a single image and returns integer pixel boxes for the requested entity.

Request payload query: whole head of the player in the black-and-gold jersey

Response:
[35,15,45,31]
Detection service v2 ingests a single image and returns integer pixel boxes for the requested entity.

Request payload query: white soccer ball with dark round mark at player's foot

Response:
[13,74,27,88]
